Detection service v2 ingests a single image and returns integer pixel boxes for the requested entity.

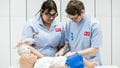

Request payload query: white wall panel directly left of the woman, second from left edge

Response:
[10,0,26,68]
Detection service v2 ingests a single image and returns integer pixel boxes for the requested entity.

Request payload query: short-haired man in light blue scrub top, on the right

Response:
[56,0,102,65]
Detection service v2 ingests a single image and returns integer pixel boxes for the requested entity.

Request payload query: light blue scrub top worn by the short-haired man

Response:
[65,16,102,65]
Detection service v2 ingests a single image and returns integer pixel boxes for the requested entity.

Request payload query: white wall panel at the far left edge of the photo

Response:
[0,0,10,68]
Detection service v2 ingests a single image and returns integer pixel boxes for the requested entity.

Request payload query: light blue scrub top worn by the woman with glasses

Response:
[22,16,65,56]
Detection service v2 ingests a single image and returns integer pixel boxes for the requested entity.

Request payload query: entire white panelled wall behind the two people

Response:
[0,0,120,68]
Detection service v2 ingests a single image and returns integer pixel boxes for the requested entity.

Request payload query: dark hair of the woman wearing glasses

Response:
[36,0,58,15]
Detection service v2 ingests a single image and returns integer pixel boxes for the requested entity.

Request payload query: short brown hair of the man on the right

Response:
[66,0,85,15]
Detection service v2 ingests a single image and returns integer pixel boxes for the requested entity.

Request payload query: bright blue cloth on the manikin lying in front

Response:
[66,54,84,68]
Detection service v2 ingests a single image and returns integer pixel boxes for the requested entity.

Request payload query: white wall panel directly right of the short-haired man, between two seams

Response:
[95,0,112,64]
